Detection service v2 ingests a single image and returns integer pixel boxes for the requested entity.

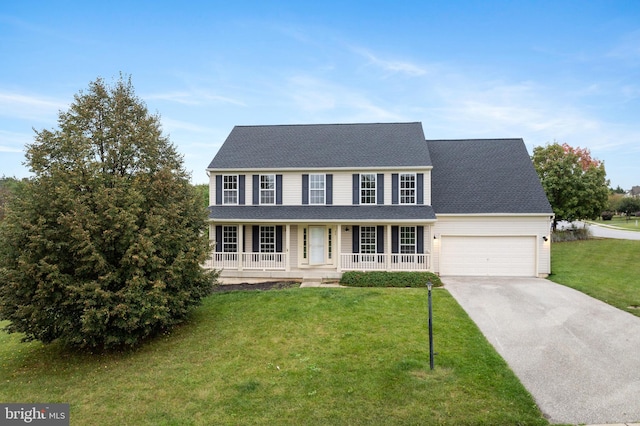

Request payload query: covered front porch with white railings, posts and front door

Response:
[204,223,432,280]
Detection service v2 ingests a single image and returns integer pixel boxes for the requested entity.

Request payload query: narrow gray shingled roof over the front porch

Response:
[209,205,436,223]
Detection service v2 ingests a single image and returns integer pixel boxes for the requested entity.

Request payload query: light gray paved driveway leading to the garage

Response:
[444,277,640,424]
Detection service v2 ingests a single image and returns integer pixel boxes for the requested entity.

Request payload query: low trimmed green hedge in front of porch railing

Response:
[340,271,442,288]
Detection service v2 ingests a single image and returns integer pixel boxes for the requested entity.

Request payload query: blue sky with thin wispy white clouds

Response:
[0,0,640,189]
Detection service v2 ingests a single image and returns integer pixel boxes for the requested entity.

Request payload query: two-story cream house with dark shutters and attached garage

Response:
[207,123,553,279]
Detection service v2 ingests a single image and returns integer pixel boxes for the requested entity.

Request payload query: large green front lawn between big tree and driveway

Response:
[0,288,547,425]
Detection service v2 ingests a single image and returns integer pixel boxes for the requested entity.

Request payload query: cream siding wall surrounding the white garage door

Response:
[432,215,551,276]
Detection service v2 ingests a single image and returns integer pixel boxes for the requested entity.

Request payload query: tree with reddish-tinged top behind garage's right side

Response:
[532,142,609,229]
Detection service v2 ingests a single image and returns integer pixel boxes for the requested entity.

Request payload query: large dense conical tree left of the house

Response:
[0,76,215,350]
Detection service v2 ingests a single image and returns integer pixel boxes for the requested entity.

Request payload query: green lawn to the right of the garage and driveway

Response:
[549,239,640,316]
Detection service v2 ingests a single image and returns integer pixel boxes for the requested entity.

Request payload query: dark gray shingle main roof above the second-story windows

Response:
[209,123,431,169]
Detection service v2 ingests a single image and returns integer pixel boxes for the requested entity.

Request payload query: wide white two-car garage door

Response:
[440,236,536,277]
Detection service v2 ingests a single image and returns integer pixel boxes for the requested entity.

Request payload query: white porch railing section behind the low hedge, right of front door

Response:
[340,253,430,271]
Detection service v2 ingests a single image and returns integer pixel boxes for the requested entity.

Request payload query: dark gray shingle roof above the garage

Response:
[427,139,552,214]
